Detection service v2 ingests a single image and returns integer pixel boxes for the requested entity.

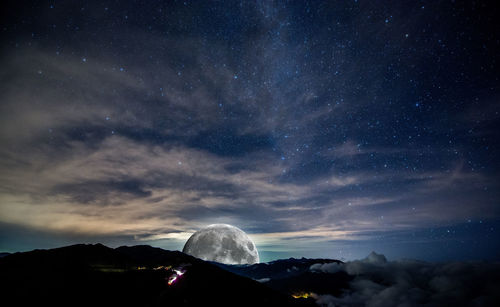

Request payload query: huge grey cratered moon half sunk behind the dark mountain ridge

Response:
[182,224,259,264]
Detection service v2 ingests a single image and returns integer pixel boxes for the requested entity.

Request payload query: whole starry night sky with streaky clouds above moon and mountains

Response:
[0,0,500,261]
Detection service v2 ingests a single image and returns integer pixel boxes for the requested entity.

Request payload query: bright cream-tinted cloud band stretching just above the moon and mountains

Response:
[0,127,496,250]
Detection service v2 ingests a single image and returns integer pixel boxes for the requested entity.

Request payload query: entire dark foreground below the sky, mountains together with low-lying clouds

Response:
[0,244,500,307]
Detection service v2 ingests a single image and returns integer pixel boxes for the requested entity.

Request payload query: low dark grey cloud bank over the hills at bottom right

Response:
[310,252,500,307]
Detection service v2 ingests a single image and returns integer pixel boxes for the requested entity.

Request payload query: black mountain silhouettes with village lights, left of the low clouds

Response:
[0,244,342,306]
